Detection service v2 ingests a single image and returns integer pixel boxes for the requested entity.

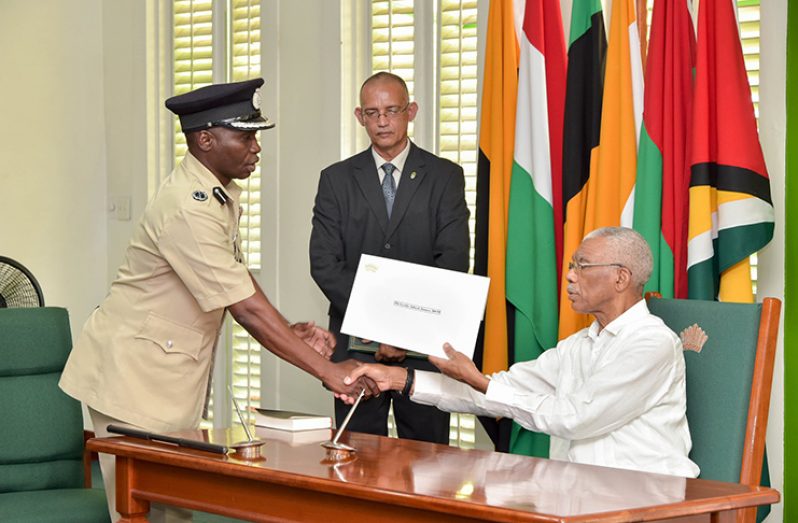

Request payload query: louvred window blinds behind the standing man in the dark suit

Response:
[369,0,477,448]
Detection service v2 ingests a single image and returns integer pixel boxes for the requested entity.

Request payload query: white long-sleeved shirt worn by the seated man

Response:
[412,300,699,477]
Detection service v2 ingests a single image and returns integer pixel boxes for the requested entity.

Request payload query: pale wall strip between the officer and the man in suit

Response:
[259,0,348,414]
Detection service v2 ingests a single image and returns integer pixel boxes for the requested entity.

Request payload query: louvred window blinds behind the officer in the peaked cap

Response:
[172,0,262,426]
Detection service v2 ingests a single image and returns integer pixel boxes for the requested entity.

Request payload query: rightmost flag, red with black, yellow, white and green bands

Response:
[687,0,774,302]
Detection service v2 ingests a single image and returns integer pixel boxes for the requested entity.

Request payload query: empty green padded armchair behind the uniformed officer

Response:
[0,307,110,523]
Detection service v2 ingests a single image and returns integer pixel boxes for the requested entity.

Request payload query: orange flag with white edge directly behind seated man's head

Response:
[559,0,643,338]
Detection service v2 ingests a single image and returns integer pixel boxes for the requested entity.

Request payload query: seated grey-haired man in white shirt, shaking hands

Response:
[345,227,699,477]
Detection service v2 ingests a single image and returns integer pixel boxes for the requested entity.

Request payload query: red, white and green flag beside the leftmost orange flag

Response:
[506,0,566,457]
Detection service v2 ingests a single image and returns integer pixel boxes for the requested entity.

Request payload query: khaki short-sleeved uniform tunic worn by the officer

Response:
[59,153,255,431]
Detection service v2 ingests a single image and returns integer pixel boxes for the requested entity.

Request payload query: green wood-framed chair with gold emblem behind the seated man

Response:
[648,297,781,523]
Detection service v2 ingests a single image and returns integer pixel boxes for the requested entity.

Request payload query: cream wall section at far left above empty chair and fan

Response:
[0,0,108,334]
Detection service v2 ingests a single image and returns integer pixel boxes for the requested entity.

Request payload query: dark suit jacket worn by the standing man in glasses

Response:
[310,143,469,369]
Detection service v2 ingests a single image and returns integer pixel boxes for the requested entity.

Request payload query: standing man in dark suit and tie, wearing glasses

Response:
[310,72,469,443]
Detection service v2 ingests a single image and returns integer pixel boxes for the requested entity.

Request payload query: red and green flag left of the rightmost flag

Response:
[634,0,695,298]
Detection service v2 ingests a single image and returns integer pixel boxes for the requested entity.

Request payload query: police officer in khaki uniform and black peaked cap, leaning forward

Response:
[60,79,376,520]
